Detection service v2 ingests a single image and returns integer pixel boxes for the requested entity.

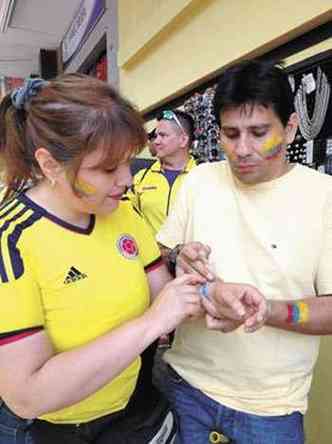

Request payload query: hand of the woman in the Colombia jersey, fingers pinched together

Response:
[145,274,205,336]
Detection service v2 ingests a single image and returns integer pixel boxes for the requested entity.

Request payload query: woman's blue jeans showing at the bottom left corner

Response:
[0,400,33,444]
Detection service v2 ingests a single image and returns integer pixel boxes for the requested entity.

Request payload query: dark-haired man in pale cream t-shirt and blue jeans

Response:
[157,61,332,444]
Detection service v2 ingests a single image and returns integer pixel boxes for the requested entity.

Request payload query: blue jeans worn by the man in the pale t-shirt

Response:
[167,366,304,444]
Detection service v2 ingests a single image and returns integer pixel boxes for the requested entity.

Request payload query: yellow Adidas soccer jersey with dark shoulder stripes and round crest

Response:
[0,194,161,423]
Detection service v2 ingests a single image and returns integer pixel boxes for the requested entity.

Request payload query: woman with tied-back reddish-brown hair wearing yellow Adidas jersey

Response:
[0,74,202,444]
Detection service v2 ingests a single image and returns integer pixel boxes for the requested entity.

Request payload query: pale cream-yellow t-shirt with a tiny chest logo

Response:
[157,161,332,415]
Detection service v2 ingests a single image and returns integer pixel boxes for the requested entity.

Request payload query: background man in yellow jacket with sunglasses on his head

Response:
[129,110,196,238]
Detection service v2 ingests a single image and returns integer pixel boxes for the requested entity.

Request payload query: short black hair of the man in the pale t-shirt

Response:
[213,60,295,126]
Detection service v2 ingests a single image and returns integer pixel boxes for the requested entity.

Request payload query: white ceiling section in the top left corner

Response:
[0,0,81,77]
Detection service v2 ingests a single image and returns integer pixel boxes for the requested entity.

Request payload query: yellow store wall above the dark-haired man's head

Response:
[118,0,332,111]
